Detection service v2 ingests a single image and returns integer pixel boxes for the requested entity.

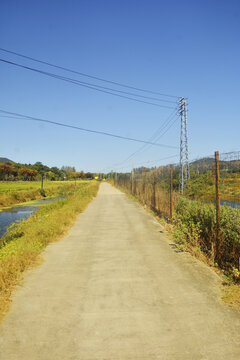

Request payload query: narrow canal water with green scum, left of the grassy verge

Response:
[0,198,63,237]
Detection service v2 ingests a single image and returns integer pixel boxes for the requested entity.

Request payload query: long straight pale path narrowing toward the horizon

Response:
[0,183,240,360]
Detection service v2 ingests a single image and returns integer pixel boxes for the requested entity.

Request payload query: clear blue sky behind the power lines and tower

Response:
[0,0,240,171]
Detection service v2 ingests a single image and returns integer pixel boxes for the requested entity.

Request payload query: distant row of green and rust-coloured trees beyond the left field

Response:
[0,161,94,181]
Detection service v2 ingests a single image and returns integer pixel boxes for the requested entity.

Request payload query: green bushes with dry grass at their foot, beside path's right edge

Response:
[173,198,240,307]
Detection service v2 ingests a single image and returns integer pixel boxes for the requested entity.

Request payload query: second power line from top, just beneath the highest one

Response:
[0,59,174,109]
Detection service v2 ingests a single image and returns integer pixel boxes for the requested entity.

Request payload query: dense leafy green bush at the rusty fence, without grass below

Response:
[174,198,240,269]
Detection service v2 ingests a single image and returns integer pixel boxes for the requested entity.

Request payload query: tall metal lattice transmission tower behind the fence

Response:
[179,98,190,193]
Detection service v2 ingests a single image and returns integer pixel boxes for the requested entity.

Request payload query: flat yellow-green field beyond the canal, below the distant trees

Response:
[0,181,84,208]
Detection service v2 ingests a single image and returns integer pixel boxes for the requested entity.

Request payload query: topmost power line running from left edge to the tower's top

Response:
[0,48,180,99]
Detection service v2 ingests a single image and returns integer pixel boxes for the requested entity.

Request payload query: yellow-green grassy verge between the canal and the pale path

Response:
[0,181,99,319]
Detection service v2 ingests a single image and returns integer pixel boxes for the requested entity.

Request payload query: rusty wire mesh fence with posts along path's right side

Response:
[112,152,240,272]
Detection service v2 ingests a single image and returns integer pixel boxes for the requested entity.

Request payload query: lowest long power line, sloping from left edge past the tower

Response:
[0,109,177,149]
